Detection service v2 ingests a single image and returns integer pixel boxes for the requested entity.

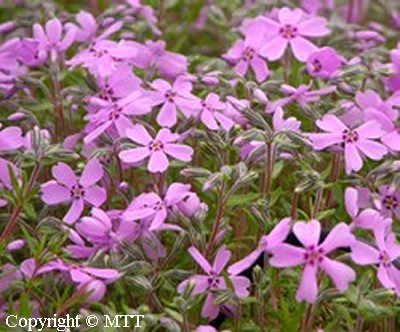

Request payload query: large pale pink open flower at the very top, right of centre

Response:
[260,7,329,62]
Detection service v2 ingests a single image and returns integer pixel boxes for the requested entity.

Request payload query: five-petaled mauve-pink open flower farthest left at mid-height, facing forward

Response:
[41,159,107,224]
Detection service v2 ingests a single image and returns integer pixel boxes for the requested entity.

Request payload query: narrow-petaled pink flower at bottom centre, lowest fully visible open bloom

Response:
[178,246,250,320]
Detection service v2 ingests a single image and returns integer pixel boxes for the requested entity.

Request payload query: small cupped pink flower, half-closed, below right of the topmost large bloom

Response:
[307,47,344,79]
